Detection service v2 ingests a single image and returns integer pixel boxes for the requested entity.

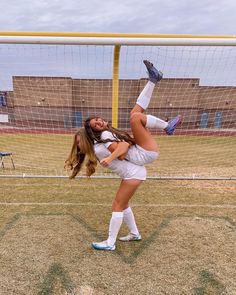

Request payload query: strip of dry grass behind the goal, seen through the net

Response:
[0,134,236,178]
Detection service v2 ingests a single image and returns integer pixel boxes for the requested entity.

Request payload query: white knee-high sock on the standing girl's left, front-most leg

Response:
[107,212,124,246]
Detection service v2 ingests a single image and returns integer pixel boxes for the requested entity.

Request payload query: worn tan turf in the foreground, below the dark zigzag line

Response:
[0,214,236,295]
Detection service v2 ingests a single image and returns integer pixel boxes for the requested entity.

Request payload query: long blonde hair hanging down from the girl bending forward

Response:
[64,128,97,179]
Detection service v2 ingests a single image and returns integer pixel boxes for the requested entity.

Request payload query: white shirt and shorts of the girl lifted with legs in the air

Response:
[101,131,159,166]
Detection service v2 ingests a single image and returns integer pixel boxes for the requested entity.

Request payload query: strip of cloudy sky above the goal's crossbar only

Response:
[0,0,236,35]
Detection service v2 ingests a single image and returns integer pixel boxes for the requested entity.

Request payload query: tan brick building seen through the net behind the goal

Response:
[0,76,236,128]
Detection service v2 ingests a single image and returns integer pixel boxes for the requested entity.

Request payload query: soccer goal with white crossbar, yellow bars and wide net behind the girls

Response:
[0,33,236,179]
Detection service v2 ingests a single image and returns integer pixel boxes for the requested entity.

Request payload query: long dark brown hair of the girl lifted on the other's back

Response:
[84,117,135,145]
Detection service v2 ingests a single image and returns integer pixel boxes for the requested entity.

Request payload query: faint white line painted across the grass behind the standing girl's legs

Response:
[0,202,236,209]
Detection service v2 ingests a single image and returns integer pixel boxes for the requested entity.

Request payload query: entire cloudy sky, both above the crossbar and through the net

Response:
[0,0,236,89]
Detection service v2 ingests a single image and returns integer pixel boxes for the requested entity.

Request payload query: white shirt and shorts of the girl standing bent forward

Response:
[94,143,147,180]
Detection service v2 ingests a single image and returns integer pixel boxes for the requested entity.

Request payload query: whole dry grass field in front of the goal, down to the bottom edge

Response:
[0,178,236,295]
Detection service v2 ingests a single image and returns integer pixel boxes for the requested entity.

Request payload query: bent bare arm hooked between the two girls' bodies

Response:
[100,141,130,167]
